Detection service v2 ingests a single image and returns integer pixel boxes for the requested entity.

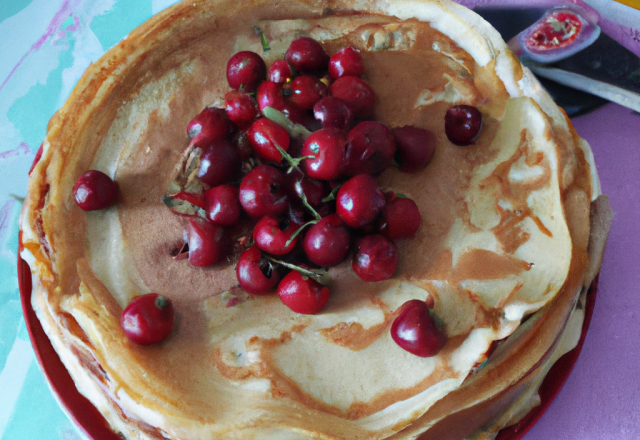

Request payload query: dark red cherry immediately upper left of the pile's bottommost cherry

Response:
[236,246,280,295]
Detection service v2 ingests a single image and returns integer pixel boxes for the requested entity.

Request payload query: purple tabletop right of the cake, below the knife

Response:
[525,104,640,440]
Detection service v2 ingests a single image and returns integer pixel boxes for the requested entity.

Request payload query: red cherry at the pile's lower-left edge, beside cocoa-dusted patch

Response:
[185,218,229,267]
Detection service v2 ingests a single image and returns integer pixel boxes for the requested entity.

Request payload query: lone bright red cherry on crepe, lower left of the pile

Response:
[120,293,174,345]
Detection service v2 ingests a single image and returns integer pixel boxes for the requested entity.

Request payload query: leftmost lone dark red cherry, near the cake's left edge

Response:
[73,170,118,211]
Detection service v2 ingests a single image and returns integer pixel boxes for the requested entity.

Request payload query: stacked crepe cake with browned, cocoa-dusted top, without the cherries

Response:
[21,0,606,440]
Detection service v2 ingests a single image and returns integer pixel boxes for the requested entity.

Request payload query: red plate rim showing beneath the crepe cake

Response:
[18,237,598,440]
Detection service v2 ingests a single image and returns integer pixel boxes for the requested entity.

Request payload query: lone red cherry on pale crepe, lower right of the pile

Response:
[391,299,446,357]
